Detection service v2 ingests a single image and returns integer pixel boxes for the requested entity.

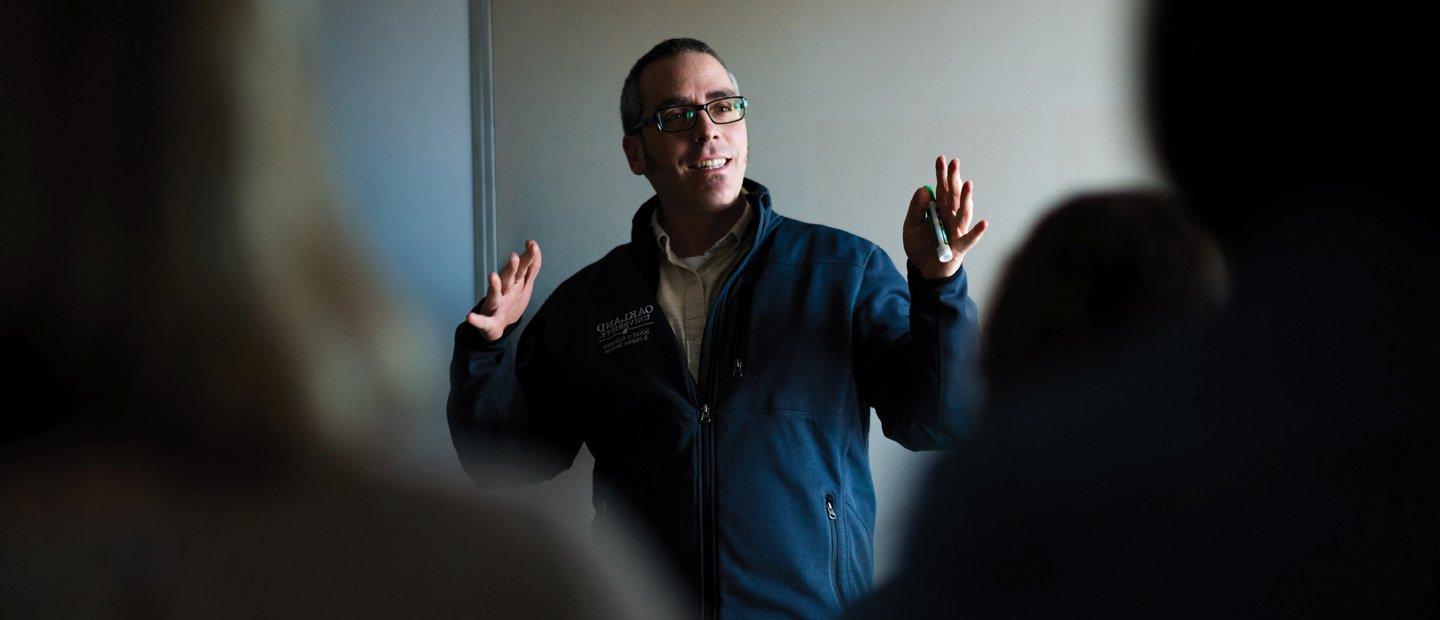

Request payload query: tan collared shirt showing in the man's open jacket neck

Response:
[649,200,755,381]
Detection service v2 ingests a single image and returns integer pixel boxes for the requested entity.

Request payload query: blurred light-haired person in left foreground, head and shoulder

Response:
[0,0,664,617]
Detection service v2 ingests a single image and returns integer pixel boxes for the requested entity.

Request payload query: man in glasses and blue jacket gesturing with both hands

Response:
[449,39,985,617]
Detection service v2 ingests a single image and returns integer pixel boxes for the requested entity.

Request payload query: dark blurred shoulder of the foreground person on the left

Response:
[0,468,654,617]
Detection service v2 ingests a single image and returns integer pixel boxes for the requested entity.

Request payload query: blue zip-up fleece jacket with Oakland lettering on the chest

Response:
[448,180,979,617]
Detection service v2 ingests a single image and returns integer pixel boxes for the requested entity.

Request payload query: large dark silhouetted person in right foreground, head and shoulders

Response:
[858,0,1440,617]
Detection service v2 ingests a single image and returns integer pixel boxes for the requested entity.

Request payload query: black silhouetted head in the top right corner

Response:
[1145,0,1430,239]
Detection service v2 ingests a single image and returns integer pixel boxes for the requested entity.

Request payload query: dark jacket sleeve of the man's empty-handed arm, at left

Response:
[446,308,583,489]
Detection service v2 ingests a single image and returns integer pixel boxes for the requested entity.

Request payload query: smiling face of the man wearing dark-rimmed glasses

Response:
[624,53,750,218]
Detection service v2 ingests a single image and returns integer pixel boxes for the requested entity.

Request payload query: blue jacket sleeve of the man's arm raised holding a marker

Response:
[854,247,982,450]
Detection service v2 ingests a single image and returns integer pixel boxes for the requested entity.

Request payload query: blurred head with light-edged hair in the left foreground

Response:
[0,0,417,474]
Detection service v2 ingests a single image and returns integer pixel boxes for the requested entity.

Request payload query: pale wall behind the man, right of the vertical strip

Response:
[492,0,1158,577]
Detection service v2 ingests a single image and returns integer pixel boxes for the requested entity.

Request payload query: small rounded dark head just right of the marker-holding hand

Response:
[981,191,1225,383]
